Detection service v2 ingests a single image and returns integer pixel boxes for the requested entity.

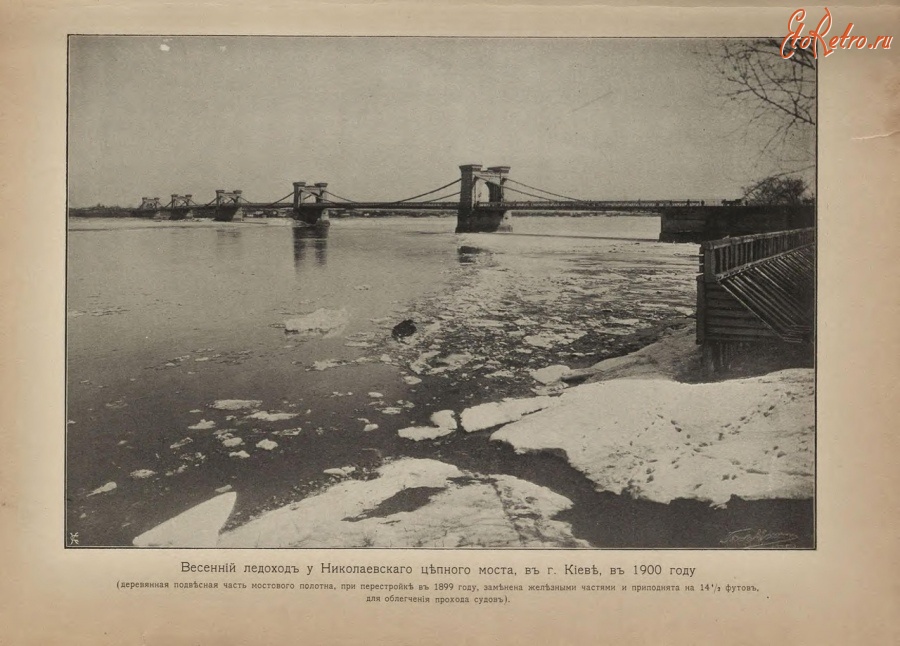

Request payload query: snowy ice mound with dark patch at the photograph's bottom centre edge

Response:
[218,459,588,548]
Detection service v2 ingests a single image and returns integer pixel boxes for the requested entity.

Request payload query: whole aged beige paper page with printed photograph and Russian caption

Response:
[0,2,900,644]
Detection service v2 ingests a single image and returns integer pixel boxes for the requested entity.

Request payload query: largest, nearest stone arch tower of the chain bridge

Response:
[456,164,512,233]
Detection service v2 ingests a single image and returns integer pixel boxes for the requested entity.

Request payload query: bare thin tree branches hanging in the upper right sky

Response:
[710,38,816,163]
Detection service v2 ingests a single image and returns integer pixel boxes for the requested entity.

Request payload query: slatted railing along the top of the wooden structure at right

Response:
[700,228,816,282]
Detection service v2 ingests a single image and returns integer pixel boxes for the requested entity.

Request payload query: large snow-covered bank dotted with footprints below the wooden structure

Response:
[491,364,815,504]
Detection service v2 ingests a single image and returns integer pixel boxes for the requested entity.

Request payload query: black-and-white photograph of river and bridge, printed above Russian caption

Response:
[67,35,817,550]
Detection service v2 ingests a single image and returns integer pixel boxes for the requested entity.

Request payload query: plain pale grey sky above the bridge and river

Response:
[69,36,814,206]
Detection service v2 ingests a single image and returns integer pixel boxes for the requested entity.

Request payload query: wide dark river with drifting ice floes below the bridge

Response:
[66,216,716,546]
